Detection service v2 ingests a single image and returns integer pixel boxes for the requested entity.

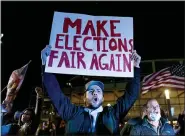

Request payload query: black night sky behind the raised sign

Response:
[1,1,184,109]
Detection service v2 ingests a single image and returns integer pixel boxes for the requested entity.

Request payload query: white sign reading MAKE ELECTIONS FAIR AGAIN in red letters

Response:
[45,12,134,77]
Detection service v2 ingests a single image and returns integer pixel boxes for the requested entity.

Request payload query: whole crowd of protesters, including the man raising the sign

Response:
[1,46,185,136]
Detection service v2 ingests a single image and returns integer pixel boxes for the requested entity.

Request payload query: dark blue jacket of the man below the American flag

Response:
[130,117,175,136]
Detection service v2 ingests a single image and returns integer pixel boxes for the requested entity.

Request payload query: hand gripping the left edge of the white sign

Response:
[41,45,51,65]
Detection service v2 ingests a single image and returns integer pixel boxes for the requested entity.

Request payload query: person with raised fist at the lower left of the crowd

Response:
[1,87,43,136]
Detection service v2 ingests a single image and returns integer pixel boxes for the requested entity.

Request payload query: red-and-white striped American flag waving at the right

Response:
[142,64,185,94]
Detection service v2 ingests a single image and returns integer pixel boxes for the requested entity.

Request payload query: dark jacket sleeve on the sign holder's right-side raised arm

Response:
[113,68,140,119]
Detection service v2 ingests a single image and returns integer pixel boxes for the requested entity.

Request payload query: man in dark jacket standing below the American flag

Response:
[130,99,175,136]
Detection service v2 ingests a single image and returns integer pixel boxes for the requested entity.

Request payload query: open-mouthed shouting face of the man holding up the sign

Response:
[84,85,104,109]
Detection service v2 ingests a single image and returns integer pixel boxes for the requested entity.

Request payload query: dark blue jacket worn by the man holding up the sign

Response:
[44,68,140,135]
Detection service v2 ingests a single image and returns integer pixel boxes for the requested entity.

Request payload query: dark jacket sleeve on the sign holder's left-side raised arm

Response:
[44,73,82,121]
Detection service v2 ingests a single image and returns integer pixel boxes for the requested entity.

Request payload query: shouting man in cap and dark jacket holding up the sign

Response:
[41,46,141,135]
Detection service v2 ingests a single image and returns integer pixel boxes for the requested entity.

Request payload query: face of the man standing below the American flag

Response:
[146,99,161,121]
